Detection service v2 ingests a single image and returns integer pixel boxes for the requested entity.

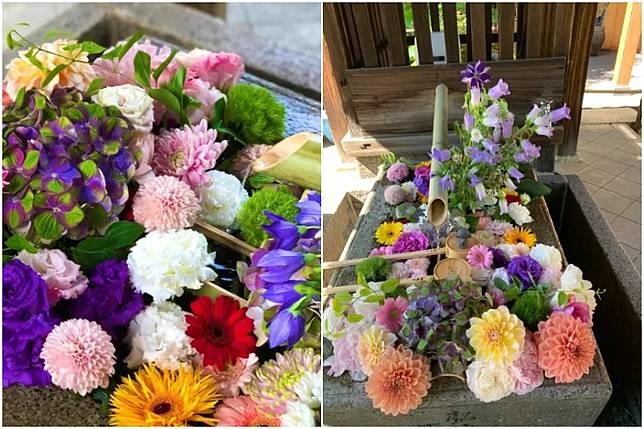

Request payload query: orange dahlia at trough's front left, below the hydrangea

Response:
[366,346,431,416]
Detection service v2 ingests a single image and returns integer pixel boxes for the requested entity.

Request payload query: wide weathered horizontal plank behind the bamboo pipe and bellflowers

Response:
[347,58,566,135]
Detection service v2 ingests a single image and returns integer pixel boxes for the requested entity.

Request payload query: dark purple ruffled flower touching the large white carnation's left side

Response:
[67,259,144,342]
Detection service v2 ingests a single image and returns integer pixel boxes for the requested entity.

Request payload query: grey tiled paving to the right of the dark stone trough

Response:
[555,124,642,275]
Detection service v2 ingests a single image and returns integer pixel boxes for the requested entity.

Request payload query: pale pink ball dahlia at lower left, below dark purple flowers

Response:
[40,319,115,396]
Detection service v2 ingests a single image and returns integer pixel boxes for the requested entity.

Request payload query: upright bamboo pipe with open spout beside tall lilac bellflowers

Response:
[427,83,449,227]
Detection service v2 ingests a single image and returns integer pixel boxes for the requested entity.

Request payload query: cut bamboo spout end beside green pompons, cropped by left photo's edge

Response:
[253,133,322,191]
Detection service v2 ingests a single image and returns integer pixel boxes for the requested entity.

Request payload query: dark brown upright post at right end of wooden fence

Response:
[555,3,600,156]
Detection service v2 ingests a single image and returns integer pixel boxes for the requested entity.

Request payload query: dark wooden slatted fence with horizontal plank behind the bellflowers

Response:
[323,3,597,160]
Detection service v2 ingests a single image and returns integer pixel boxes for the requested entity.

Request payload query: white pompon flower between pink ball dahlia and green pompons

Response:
[199,170,248,228]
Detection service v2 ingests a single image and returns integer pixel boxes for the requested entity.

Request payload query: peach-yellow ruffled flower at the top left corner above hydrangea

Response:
[6,39,96,100]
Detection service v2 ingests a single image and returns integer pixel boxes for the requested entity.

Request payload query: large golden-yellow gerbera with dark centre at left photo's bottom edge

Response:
[110,364,221,426]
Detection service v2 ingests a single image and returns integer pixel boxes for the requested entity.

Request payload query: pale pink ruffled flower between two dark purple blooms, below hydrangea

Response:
[17,249,88,306]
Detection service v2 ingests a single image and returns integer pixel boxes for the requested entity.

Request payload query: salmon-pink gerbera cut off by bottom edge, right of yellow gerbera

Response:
[215,396,281,427]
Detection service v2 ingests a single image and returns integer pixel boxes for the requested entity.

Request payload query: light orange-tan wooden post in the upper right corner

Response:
[613,2,642,86]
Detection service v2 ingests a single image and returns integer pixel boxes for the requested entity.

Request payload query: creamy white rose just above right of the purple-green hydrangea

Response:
[92,84,154,133]
